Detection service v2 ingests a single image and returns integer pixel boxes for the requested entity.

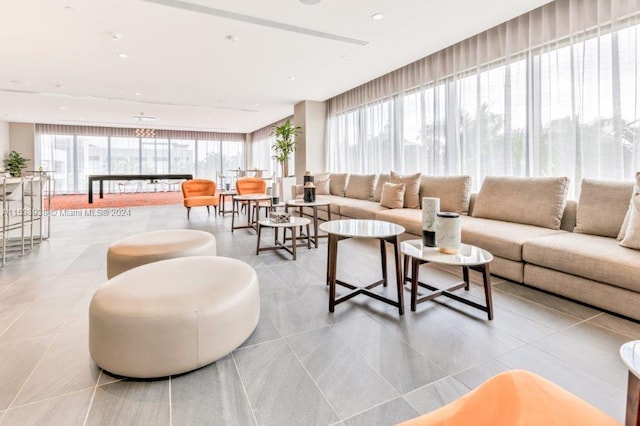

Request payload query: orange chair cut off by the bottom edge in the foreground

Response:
[400,370,620,426]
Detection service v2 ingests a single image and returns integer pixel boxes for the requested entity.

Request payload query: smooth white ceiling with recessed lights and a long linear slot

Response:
[0,0,548,132]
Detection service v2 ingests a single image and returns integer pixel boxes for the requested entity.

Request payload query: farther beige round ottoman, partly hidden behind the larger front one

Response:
[107,229,216,278]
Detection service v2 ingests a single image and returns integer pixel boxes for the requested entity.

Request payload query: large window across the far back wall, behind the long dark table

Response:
[39,130,245,194]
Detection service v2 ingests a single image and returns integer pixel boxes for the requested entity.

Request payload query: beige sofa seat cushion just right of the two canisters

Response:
[460,215,565,262]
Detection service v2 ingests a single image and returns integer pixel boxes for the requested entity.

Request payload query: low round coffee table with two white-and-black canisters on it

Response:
[400,240,493,320]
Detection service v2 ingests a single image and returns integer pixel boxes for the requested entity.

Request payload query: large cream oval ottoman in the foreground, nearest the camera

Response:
[89,256,260,378]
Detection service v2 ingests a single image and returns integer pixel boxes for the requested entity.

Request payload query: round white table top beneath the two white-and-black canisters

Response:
[400,240,493,266]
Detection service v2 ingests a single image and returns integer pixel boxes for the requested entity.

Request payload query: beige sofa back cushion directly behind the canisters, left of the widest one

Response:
[420,176,471,213]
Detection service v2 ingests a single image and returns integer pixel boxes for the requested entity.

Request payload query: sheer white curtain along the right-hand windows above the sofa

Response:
[327,0,640,197]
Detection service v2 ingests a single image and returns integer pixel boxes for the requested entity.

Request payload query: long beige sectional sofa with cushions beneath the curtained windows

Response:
[292,173,640,320]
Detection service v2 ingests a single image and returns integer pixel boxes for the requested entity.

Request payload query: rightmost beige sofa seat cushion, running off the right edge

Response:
[523,232,640,292]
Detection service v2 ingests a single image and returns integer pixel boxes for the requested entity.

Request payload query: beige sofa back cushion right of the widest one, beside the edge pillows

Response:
[573,179,633,238]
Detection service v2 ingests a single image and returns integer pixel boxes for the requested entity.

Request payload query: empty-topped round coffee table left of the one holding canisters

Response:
[320,219,404,315]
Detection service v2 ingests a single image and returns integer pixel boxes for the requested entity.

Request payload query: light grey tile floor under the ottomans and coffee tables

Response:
[0,206,640,425]
